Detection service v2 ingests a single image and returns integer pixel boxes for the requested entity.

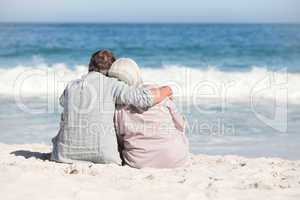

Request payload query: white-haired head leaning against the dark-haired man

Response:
[108,58,142,86]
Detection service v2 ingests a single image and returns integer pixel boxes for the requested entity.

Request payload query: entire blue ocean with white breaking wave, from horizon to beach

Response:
[0,23,300,159]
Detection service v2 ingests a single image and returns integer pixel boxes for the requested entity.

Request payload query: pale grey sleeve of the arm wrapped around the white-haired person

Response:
[112,79,154,109]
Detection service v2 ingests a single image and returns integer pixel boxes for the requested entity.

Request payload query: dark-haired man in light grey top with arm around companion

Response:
[51,50,172,164]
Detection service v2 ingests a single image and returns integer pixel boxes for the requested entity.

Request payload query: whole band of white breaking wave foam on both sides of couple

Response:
[0,64,300,104]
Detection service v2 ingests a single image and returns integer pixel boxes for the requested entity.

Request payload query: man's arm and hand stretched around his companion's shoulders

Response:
[112,79,172,108]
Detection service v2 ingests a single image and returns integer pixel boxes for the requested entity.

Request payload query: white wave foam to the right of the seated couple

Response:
[143,66,300,103]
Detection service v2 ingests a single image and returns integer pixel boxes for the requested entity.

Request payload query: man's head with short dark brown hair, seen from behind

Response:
[89,50,116,75]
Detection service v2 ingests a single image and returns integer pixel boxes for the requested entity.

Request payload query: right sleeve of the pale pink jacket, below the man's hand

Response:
[164,99,187,131]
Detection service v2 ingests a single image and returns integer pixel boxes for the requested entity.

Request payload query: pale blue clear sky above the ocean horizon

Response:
[0,0,300,23]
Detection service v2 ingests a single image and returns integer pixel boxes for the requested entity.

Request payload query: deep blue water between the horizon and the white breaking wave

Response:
[0,24,300,71]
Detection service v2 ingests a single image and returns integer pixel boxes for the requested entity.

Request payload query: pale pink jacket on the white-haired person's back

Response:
[115,99,189,168]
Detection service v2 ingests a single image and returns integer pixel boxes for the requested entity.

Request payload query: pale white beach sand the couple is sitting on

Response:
[0,144,300,200]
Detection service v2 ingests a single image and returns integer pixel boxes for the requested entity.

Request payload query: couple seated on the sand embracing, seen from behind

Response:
[51,50,189,168]
